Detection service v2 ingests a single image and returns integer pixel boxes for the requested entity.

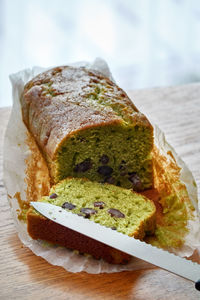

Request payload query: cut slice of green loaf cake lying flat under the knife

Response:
[27,178,156,264]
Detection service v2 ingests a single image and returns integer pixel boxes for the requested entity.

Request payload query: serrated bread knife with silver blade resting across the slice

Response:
[30,202,200,290]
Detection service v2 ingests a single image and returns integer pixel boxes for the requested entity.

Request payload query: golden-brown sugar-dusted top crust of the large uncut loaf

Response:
[21,66,151,159]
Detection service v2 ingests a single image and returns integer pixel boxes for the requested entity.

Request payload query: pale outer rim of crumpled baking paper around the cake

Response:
[4,59,200,274]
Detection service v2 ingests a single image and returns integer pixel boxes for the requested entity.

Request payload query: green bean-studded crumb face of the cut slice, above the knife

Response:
[35,178,156,237]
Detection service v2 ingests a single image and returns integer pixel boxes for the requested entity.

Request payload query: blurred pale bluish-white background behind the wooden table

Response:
[0,0,200,106]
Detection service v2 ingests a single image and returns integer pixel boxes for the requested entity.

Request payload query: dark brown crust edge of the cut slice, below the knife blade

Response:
[27,208,131,264]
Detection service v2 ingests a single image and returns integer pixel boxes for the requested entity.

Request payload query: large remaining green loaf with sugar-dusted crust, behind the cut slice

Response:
[21,66,153,191]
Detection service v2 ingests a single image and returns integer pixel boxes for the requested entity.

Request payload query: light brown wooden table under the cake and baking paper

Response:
[0,84,200,300]
